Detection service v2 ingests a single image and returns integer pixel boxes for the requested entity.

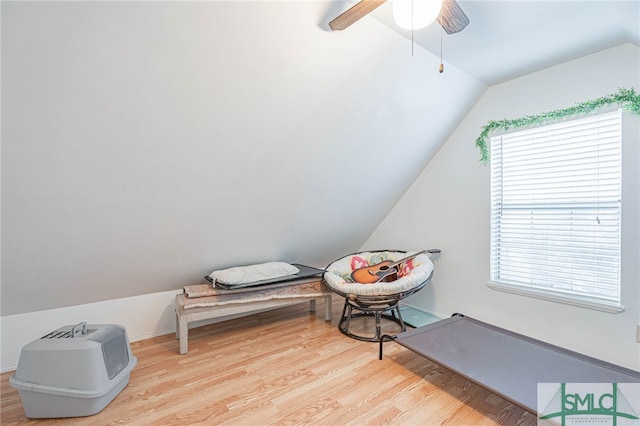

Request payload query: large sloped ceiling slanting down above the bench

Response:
[1,2,486,315]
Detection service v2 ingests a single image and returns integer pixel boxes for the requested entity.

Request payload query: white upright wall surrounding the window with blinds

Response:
[363,44,640,370]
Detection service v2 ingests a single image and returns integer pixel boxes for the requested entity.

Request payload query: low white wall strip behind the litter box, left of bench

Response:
[0,291,180,372]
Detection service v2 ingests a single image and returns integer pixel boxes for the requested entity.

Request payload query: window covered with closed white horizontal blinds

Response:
[489,110,624,312]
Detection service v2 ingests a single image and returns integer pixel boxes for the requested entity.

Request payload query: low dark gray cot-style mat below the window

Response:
[380,314,640,413]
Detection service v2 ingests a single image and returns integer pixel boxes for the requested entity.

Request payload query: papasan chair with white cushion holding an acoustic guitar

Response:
[323,249,440,342]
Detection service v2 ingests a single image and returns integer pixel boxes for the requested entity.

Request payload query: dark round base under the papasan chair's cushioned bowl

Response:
[338,298,407,342]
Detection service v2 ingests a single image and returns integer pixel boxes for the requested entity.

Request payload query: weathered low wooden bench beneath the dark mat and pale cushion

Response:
[175,279,332,354]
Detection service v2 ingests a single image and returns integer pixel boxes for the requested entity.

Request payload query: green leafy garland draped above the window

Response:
[476,88,640,164]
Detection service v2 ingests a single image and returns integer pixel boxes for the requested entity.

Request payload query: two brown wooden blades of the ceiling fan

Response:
[329,0,469,34]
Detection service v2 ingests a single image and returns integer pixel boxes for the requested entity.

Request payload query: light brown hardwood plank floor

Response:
[0,297,536,426]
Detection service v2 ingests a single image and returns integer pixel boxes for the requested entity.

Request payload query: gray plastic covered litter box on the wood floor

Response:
[9,323,137,418]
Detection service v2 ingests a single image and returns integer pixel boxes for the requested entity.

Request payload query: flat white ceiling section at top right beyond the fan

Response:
[364,0,640,85]
